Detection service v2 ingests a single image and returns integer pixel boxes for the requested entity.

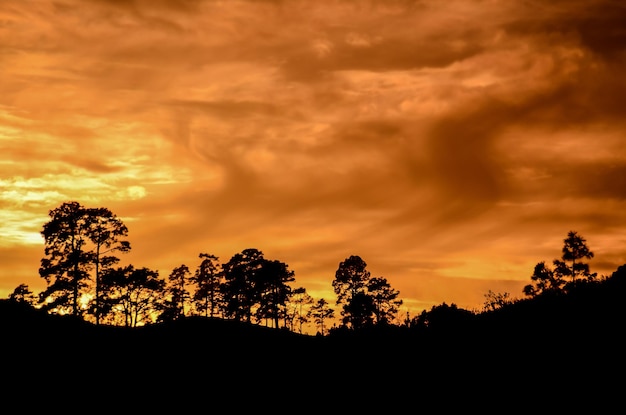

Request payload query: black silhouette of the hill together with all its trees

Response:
[0,202,626,415]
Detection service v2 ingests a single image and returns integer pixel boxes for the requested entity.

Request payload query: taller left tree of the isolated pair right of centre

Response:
[332,255,374,329]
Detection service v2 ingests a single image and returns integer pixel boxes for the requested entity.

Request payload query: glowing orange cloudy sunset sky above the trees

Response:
[0,0,626,315]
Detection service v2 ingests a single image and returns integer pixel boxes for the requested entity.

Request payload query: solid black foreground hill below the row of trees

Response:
[0,267,626,414]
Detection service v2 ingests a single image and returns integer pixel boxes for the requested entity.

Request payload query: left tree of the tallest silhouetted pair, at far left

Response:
[39,202,94,316]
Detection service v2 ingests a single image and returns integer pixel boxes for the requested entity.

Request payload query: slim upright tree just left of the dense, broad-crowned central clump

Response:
[190,253,224,317]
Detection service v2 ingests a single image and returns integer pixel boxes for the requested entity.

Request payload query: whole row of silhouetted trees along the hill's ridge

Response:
[9,201,606,336]
